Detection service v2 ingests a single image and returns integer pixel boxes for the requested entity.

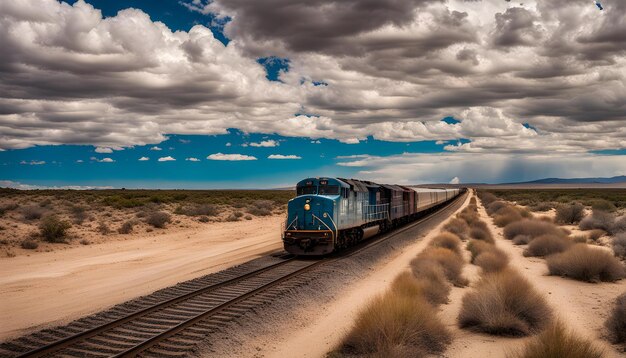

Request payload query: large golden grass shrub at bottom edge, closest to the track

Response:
[339,291,451,357]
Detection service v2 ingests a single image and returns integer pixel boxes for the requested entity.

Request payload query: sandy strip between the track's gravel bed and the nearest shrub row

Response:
[224,193,469,358]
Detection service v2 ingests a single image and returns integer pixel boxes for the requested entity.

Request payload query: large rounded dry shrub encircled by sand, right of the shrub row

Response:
[458,269,552,336]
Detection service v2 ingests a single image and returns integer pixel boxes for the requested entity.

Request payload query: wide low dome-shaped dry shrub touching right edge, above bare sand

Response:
[547,244,626,282]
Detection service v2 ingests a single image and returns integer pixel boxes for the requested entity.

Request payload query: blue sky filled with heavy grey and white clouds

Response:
[0,0,626,189]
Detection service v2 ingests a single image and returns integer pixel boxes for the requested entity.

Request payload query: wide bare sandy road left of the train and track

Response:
[0,216,283,340]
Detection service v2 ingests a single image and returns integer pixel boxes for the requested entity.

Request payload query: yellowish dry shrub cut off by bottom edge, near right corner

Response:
[509,321,604,358]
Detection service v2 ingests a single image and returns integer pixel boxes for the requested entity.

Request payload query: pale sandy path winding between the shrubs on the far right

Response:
[443,197,626,358]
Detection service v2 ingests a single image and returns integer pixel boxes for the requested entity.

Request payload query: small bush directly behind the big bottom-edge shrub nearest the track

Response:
[411,257,450,305]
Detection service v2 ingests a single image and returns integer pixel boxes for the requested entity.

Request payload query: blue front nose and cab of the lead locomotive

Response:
[283,178,349,255]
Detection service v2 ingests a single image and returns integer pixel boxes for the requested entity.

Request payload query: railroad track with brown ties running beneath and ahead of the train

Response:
[0,195,466,357]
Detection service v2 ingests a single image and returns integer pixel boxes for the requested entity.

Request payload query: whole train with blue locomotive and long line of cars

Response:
[282,178,465,256]
